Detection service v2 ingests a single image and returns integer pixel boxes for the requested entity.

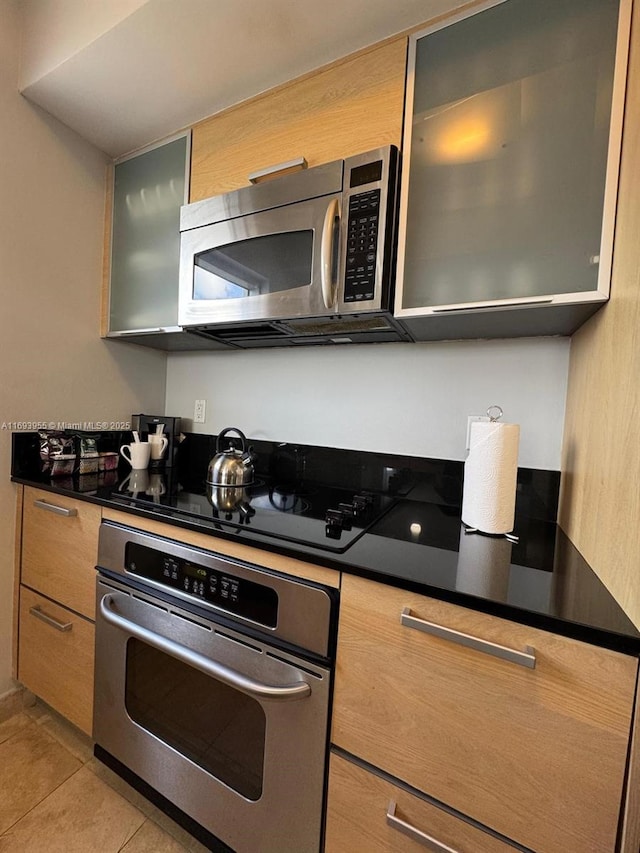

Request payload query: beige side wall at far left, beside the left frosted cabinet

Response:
[0,0,166,697]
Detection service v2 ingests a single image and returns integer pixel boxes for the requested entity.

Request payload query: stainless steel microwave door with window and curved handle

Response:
[178,194,341,326]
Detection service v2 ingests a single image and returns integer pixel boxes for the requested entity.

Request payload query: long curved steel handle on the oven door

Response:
[100,594,311,702]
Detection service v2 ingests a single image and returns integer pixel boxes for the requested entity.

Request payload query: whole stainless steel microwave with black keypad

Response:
[179,146,409,347]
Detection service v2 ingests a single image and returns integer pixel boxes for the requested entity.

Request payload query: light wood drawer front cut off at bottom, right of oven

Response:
[325,754,516,853]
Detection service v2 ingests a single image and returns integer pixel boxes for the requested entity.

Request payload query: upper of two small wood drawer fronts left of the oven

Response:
[21,487,101,619]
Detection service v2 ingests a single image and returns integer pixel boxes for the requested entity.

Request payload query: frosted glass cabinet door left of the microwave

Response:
[109,134,190,334]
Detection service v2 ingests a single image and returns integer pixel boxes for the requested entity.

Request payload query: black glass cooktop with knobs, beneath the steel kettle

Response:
[110,474,394,553]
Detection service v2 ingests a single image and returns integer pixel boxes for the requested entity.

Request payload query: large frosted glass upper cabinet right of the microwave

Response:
[396,0,631,340]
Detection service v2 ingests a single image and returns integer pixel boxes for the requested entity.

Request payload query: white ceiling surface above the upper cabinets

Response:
[16,0,460,157]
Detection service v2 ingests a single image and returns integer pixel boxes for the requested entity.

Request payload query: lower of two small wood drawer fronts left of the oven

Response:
[18,586,95,734]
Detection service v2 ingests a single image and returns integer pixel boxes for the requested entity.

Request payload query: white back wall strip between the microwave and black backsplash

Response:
[166,338,569,470]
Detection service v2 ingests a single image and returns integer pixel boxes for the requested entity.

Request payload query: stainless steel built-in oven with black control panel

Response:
[93,522,333,853]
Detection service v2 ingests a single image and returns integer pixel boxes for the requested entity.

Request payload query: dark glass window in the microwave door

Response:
[193,230,313,299]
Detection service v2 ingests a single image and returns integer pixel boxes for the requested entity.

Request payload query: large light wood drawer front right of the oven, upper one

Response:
[332,576,637,853]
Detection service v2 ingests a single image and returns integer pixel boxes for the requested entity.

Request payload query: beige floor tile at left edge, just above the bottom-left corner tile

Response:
[0,722,82,832]
